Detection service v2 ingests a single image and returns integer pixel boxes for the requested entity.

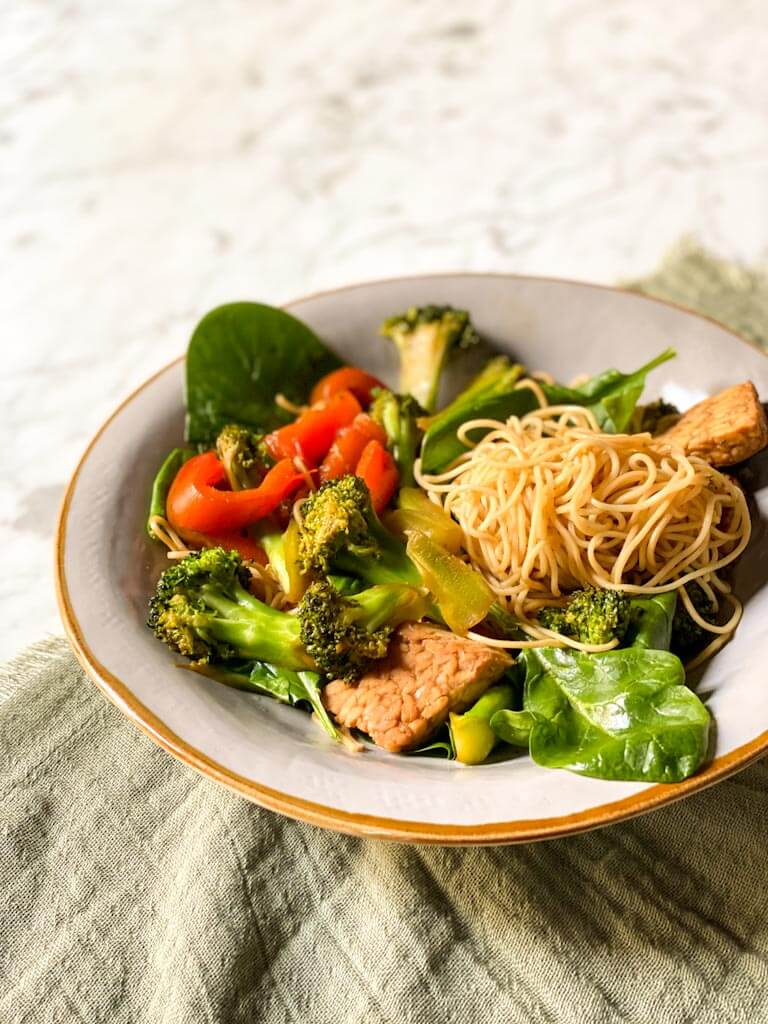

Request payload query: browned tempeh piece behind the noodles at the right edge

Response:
[658,381,768,466]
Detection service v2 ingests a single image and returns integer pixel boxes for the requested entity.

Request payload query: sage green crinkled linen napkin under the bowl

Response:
[0,244,768,1024]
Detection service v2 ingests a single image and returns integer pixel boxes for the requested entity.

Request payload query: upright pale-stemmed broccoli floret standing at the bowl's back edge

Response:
[379,306,478,413]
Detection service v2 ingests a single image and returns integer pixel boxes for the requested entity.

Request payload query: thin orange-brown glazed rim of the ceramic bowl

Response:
[54,271,768,846]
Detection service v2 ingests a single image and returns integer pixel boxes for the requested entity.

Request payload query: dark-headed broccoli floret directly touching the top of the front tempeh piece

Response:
[299,582,428,681]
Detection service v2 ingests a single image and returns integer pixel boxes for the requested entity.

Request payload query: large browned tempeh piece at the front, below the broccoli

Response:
[323,623,512,752]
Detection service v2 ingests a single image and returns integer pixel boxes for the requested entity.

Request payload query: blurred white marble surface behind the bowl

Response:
[0,0,768,656]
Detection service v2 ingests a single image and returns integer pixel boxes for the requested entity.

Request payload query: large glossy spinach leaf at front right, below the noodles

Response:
[521,647,710,782]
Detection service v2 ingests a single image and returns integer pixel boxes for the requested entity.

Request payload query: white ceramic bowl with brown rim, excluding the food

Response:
[57,274,768,844]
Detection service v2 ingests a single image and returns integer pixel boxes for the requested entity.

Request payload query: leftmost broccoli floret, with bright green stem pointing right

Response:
[147,548,314,670]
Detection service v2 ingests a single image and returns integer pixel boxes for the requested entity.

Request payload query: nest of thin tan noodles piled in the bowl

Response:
[417,406,750,659]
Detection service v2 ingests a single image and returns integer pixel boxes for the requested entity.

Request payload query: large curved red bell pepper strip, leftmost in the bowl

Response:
[166,452,304,535]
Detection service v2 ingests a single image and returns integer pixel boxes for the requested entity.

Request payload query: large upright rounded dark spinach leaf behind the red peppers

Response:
[186,302,341,444]
